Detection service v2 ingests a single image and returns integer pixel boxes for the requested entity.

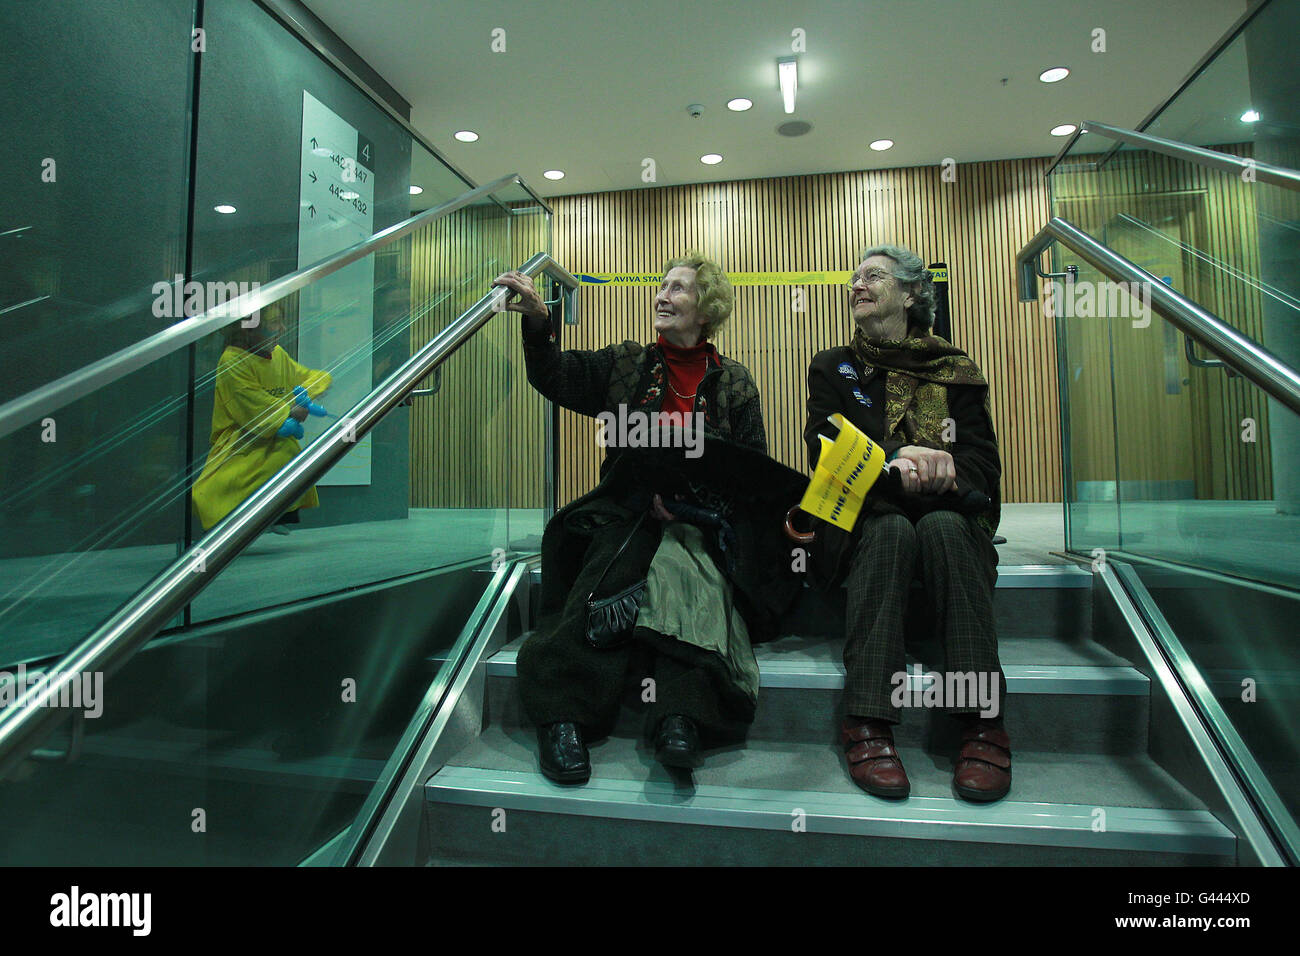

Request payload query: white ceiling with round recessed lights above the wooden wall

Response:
[306,0,1245,196]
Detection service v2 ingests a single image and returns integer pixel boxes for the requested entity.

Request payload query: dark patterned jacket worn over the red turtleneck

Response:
[524,319,767,479]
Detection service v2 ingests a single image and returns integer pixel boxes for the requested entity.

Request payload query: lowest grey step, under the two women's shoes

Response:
[425,728,1236,865]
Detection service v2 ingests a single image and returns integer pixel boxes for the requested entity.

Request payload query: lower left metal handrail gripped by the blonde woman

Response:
[0,252,579,778]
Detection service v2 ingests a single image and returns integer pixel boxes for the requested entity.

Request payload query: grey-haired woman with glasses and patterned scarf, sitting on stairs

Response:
[803,246,1011,801]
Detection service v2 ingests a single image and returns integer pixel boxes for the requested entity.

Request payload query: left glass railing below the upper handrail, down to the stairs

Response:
[0,175,550,864]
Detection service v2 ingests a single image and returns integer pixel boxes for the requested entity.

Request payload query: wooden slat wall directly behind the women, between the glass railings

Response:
[553,159,1061,502]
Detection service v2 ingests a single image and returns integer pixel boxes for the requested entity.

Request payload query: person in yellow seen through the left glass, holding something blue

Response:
[194,320,333,532]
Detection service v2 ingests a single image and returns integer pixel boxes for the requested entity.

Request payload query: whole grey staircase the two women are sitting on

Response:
[424,566,1238,866]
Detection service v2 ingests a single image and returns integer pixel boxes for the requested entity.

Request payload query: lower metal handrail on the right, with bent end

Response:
[1015,216,1300,415]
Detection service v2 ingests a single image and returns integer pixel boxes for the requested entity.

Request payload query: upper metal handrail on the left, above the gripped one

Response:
[0,173,532,438]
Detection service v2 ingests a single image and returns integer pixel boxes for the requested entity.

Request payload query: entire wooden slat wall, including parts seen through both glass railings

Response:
[411,147,1271,507]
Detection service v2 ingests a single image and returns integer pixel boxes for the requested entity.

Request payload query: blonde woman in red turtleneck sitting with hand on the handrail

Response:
[495,254,779,783]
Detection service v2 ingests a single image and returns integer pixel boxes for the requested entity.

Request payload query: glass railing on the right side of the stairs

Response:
[1043,0,1300,858]
